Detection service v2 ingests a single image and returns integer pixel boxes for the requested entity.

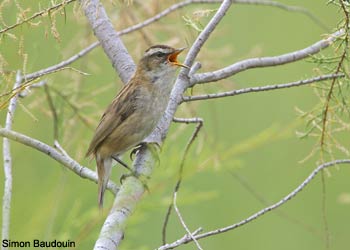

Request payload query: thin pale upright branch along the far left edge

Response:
[1,71,22,249]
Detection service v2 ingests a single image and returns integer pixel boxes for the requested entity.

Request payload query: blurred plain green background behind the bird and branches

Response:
[0,0,350,250]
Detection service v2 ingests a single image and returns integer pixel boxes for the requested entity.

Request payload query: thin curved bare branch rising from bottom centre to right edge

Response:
[158,159,350,250]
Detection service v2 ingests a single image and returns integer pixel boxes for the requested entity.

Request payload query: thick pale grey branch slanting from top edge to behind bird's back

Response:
[80,0,136,83]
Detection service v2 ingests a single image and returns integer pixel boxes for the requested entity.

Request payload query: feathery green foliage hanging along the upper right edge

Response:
[298,1,350,162]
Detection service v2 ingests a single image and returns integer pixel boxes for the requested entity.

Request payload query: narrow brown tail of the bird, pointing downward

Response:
[96,154,112,209]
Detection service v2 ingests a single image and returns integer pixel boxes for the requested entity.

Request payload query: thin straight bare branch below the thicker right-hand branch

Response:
[183,74,345,102]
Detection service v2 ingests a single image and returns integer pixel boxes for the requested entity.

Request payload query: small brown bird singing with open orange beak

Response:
[86,45,188,207]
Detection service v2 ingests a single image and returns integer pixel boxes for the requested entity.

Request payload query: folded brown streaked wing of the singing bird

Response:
[86,83,139,156]
